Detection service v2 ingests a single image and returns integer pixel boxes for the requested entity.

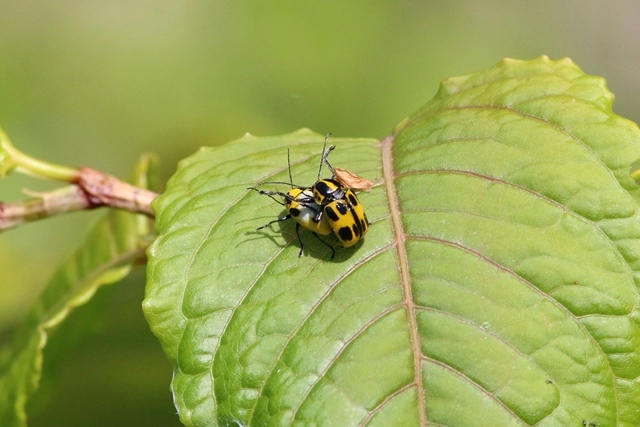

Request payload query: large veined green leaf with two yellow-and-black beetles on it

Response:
[144,57,640,426]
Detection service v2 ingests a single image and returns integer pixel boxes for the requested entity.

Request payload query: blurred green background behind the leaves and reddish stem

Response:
[0,0,640,425]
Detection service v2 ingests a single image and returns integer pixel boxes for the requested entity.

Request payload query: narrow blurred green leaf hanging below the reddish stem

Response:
[0,157,153,426]
